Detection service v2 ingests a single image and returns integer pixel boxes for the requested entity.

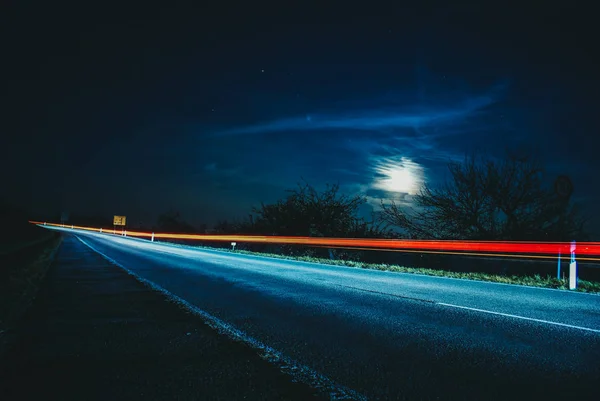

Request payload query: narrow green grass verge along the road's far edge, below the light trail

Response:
[159,243,600,293]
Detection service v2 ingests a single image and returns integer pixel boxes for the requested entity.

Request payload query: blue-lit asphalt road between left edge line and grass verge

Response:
[36,232,600,400]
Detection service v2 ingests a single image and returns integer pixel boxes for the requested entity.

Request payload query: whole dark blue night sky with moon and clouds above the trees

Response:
[0,1,600,232]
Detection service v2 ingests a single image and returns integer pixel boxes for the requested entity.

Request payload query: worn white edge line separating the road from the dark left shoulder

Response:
[75,235,367,400]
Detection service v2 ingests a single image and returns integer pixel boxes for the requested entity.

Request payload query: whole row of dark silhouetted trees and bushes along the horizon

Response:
[158,155,588,241]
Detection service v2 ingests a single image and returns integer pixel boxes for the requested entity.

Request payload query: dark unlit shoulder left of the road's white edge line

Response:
[0,236,328,400]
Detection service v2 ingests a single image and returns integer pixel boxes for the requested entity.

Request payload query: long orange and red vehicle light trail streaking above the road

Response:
[30,221,600,260]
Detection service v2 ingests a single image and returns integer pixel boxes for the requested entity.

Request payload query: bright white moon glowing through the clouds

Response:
[373,157,424,195]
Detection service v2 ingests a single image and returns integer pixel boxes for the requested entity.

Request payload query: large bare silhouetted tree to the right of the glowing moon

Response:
[382,155,586,241]
